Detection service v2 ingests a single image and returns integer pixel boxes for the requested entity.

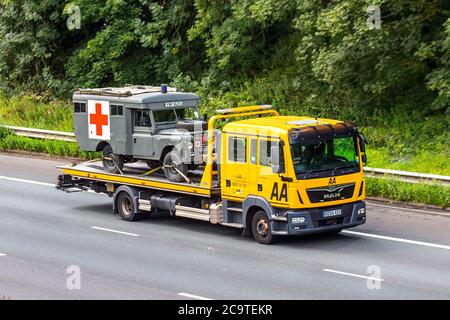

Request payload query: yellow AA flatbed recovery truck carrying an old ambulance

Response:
[57,106,366,244]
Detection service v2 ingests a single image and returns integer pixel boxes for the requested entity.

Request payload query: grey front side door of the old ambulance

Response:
[133,110,153,159]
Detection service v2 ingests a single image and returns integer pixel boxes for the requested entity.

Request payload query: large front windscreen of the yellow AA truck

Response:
[291,137,359,179]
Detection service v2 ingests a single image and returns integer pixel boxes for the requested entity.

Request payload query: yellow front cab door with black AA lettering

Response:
[258,138,289,206]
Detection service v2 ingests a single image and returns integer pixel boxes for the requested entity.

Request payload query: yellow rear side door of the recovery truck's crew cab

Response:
[222,135,249,199]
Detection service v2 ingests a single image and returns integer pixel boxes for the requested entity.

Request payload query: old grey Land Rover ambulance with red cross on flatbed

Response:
[73,86,206,181]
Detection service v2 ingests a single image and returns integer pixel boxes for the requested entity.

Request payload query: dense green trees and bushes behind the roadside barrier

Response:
[0,0,450,113]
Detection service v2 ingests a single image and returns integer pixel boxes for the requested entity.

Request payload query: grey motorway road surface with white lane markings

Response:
[0,154,450,299]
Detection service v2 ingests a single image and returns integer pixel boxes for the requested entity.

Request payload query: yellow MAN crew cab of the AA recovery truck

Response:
[221,116,365,242]
